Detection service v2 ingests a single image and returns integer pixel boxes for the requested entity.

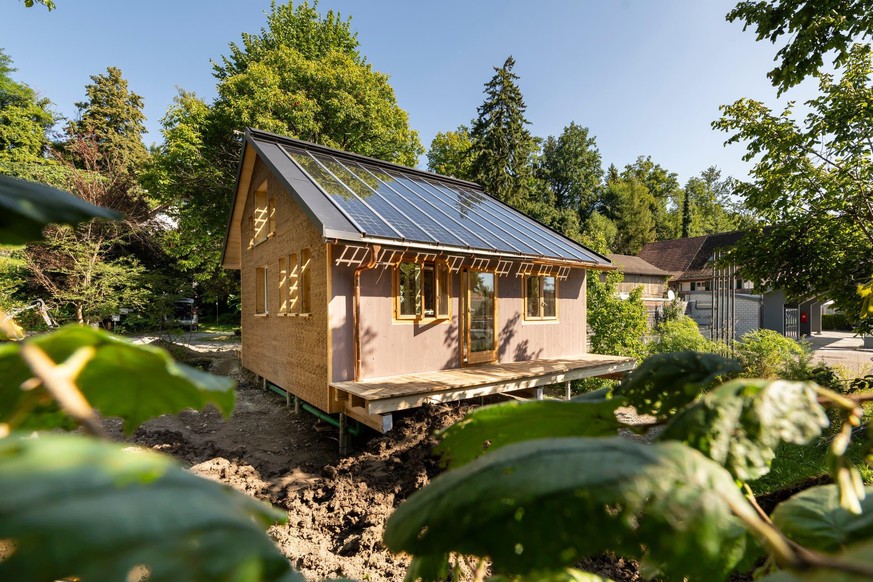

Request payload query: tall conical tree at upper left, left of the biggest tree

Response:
[67,67,148,181]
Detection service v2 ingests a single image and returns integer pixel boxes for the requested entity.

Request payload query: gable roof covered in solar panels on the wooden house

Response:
[222,129,610,268]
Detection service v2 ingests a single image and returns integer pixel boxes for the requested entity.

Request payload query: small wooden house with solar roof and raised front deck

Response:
[222,130,633,442]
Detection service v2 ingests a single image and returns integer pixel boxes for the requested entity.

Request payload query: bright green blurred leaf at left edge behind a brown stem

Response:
[0,326,236,433]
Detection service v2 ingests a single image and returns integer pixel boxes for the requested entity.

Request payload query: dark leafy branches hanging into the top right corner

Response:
[727,0,873,94]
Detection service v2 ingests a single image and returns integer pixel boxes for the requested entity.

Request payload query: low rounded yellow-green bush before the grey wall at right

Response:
[736,329,811,380]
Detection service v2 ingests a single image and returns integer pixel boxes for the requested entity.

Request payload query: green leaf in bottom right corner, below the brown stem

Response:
[771,485,873,552]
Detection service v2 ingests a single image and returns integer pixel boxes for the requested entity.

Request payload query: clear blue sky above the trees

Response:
[0,0,813,184]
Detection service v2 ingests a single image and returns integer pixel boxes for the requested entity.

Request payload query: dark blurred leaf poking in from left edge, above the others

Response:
[0,176,122,245]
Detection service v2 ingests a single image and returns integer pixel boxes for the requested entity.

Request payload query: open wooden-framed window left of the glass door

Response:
[394,262,451,319]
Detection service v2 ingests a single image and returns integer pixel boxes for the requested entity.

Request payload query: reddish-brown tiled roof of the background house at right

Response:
[639,231,745,282]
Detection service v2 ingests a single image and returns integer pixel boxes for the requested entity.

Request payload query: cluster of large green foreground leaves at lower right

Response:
[385,352,873,580]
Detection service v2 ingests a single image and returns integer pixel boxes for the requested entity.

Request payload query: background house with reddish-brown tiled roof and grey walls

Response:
[639,232,823,339]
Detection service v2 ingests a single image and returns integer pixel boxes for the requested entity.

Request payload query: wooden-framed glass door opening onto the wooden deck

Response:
[464,271,497,364]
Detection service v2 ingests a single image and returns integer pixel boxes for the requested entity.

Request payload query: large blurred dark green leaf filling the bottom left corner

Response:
[0,434,303,582]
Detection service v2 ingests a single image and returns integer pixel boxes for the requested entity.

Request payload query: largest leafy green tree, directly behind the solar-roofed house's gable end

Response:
[147,2,423,306]
